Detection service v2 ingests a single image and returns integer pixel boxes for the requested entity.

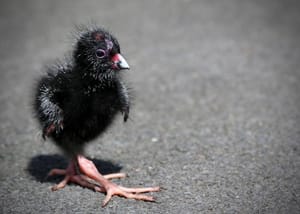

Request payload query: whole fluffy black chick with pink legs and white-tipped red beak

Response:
[34,25,159,206]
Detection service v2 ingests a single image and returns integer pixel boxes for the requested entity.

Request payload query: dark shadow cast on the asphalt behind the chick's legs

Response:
[27,154,122,183]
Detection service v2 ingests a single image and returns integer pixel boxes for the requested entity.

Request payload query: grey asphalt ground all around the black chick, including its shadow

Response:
[0,0,300,213]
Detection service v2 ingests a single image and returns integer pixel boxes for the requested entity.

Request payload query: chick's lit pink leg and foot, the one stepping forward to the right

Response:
[77,155,160,207]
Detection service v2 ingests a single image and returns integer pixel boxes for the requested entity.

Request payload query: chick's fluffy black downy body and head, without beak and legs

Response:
[35,28,129,155]
